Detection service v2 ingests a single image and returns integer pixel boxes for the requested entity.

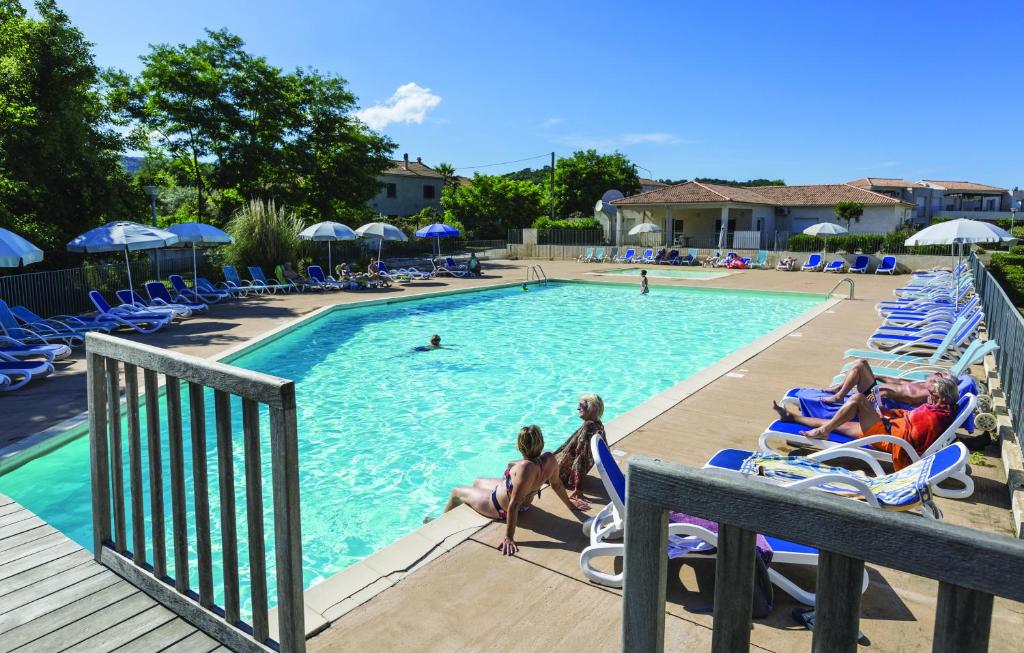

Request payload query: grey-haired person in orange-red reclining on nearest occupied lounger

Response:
[772,377,959,471]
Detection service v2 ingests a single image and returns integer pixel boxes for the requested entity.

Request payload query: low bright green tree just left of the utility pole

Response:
[441,173,546,240]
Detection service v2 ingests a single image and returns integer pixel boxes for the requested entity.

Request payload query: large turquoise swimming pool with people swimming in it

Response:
[0,282,825,618]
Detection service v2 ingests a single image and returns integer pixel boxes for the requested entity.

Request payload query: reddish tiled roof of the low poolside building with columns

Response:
[612,181,912,207]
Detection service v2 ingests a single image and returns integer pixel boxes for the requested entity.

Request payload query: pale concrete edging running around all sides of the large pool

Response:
[0,275,843,638]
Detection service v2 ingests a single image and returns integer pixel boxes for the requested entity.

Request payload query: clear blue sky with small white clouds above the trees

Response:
[54,0,1024,187]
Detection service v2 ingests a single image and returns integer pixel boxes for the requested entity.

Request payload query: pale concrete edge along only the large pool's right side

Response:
[278,292,844,638]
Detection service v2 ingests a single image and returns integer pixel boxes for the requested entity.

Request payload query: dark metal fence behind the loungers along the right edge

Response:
[971,254,1024,446]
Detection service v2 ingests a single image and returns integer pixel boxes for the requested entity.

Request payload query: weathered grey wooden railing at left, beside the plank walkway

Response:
[86,334,305,652]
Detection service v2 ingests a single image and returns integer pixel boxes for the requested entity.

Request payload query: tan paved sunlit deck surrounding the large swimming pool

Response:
[0,261,1024,652]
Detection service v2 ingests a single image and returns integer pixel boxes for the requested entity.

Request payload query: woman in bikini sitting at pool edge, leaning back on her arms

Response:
[444,426,590,556]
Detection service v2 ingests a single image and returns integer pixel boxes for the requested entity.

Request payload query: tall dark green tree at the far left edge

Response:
[0,0,135,266]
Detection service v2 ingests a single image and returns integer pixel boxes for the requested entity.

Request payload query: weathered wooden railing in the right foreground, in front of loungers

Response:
[622,455,1024,653]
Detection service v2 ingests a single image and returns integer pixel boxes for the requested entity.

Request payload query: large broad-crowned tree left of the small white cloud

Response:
[108,30,394,225]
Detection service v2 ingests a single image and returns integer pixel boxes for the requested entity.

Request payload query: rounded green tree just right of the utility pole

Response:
[555,149,640,217]
